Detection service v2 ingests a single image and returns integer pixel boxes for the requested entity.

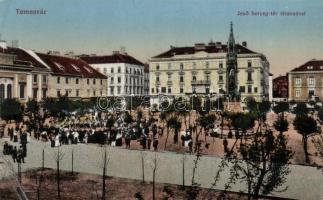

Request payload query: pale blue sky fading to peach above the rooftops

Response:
[0,0,323,76]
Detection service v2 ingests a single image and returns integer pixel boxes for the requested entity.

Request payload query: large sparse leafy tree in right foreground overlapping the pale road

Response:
[225,130,293,199]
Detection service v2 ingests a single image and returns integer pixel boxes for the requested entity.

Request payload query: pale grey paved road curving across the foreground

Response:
[0,139,323,200]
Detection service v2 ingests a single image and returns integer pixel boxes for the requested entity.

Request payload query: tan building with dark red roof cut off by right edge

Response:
[288,60,323,101]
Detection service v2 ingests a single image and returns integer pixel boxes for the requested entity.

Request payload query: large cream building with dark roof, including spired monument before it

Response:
[149,24,270,102]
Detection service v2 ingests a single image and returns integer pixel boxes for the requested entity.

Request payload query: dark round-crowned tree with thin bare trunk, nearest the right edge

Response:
[293,115,321,163]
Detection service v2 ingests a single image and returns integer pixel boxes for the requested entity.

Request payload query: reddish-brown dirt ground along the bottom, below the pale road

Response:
[0,169,284,200]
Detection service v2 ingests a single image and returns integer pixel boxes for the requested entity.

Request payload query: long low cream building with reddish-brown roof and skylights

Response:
[35,53,107,98]
